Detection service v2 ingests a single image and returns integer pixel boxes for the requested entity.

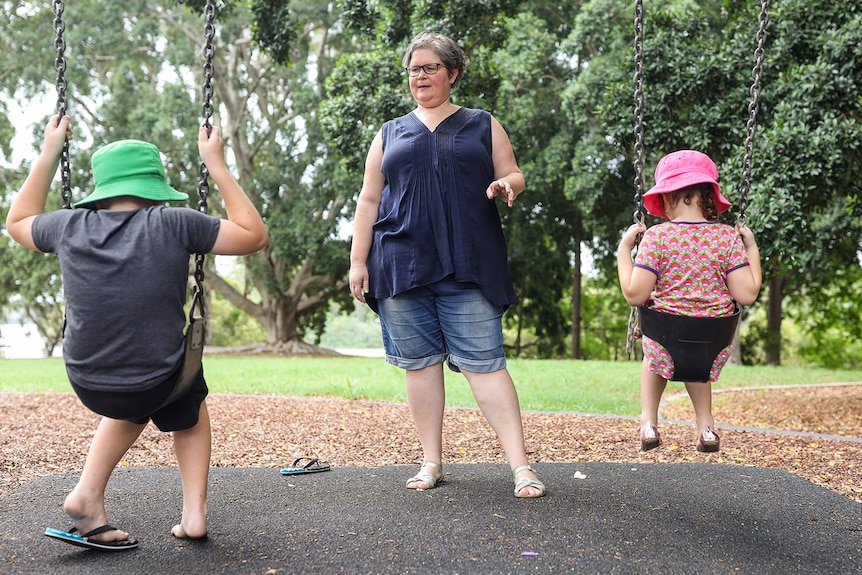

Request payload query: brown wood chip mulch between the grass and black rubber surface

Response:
[0,384,862,503]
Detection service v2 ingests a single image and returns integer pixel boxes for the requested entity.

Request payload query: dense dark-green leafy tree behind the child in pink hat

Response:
[567,0,862,363]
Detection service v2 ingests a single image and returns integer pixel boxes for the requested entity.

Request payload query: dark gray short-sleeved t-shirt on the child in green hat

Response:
[32,206,220,391]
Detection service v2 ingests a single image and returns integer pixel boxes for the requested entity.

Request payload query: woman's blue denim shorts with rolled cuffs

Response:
[377,278,506,373]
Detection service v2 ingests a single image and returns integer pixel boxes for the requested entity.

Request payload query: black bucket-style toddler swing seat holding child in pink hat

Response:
[638,306,740,383]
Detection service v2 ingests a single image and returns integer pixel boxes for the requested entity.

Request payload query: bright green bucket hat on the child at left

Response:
[75,140,189,208]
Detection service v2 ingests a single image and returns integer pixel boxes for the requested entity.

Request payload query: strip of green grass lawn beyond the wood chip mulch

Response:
[0,356,862,416]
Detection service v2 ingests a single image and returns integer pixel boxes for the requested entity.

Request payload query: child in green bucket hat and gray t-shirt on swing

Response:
[6,115,268,550]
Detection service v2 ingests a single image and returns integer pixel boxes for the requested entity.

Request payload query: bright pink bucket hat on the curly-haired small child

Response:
[644,150,730,218]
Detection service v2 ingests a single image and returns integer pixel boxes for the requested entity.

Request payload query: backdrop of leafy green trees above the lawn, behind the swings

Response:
[0,0,862,369]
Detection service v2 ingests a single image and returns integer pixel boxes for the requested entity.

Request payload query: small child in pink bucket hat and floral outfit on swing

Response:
[617,150,762,452]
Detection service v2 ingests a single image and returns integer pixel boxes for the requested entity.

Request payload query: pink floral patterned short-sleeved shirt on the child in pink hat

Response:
[635,222,749,317]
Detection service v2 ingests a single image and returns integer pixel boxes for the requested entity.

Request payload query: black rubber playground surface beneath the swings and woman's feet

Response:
[0,463,862,575]
